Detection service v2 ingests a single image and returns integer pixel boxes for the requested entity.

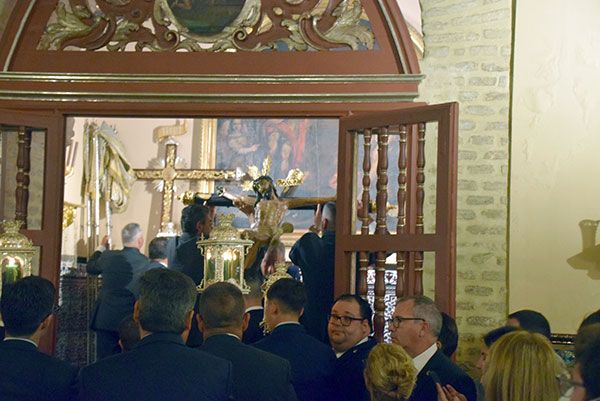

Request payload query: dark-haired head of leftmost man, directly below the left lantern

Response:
[0,276,55,337]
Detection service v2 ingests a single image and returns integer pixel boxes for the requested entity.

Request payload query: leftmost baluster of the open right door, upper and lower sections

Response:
[358,128,372,298]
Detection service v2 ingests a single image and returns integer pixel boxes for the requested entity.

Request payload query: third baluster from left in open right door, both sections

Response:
[396,125,408,298]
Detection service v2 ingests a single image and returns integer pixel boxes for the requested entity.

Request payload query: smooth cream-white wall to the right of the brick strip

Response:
[509,0,600,333]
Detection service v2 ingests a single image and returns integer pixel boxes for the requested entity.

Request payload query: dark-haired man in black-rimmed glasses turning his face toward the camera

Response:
[327,294,377,401]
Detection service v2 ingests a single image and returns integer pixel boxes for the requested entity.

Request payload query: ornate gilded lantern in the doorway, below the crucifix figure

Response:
[197,214,253,294]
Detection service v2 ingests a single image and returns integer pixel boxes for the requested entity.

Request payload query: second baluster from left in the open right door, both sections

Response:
[374,127,388,341]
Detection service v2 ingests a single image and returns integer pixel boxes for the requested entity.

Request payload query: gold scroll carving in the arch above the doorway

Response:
[38,0,375,52]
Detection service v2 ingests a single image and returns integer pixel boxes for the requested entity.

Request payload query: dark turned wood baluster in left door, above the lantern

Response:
[15,127,31,229]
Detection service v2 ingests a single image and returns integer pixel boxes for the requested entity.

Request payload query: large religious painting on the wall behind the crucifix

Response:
[215,118,339,231]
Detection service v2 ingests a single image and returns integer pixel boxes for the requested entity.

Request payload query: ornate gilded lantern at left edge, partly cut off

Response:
[0,220,36,293]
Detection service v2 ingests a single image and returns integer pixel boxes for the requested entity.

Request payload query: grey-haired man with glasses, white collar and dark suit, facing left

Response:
[390,296,477,401]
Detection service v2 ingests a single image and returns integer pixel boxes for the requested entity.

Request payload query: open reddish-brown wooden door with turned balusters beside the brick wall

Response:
[335,103,458,339]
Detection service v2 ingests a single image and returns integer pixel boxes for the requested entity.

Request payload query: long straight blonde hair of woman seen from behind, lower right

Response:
[482,331,560,401]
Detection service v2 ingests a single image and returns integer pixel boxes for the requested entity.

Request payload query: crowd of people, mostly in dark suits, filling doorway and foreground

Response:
[0,205,600,401]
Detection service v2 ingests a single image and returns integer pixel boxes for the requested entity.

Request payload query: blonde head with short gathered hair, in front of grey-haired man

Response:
[365,344,417,401]
